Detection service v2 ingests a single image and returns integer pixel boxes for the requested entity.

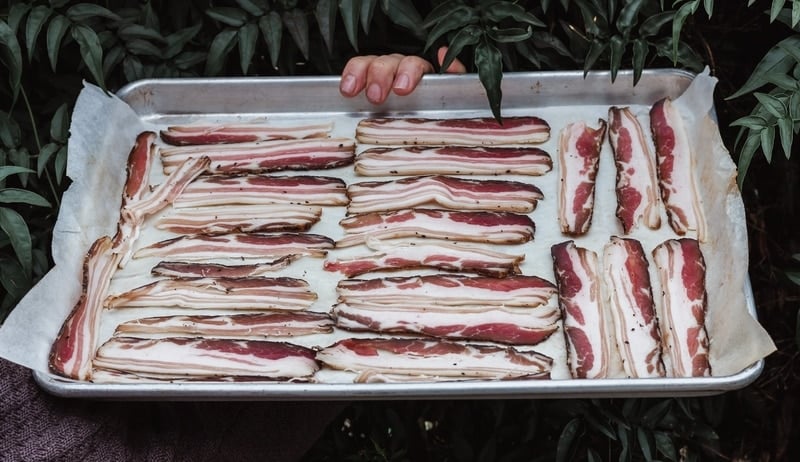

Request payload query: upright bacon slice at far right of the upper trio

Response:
[650,98,706,242]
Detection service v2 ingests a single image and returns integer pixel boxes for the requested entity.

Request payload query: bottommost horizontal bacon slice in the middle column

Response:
[317,338,553,382]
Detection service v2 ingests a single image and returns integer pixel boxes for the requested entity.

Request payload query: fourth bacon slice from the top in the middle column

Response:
[336,209,535,247]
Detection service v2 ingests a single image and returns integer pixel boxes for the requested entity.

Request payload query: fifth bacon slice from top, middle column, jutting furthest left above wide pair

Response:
[323,242,525,278]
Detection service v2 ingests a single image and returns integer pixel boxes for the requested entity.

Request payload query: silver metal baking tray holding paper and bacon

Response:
[34,70,763,400]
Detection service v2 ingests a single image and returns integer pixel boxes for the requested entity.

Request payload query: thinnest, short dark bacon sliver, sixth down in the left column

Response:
[150,255,296,278]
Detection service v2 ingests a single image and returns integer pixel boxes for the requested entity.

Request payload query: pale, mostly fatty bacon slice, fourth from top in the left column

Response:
[156,204,322,234]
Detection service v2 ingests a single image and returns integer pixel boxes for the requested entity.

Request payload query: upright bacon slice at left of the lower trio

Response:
[550,241,614,379]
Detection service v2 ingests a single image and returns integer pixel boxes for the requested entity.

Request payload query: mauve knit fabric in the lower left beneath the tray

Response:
[0,358,344,462]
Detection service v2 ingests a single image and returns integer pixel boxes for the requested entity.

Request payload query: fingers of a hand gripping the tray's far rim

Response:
[339,47,466,104]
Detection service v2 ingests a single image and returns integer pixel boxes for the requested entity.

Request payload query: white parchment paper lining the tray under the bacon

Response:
[0,71,775,381]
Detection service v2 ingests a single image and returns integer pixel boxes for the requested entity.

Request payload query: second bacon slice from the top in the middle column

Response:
[355,146,553,176]
